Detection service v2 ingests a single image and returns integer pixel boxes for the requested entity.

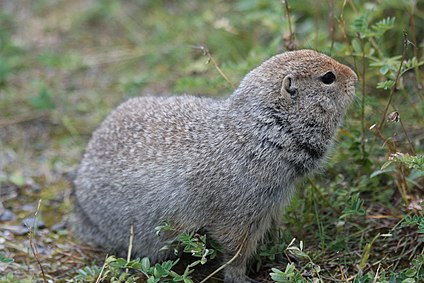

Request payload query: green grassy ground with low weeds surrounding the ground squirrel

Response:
[0,0,424,283]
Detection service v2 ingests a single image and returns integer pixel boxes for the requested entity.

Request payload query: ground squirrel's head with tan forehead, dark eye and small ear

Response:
[234,50,357,171]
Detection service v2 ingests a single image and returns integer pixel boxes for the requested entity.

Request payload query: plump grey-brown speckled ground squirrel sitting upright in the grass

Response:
[74,50,357,283]
